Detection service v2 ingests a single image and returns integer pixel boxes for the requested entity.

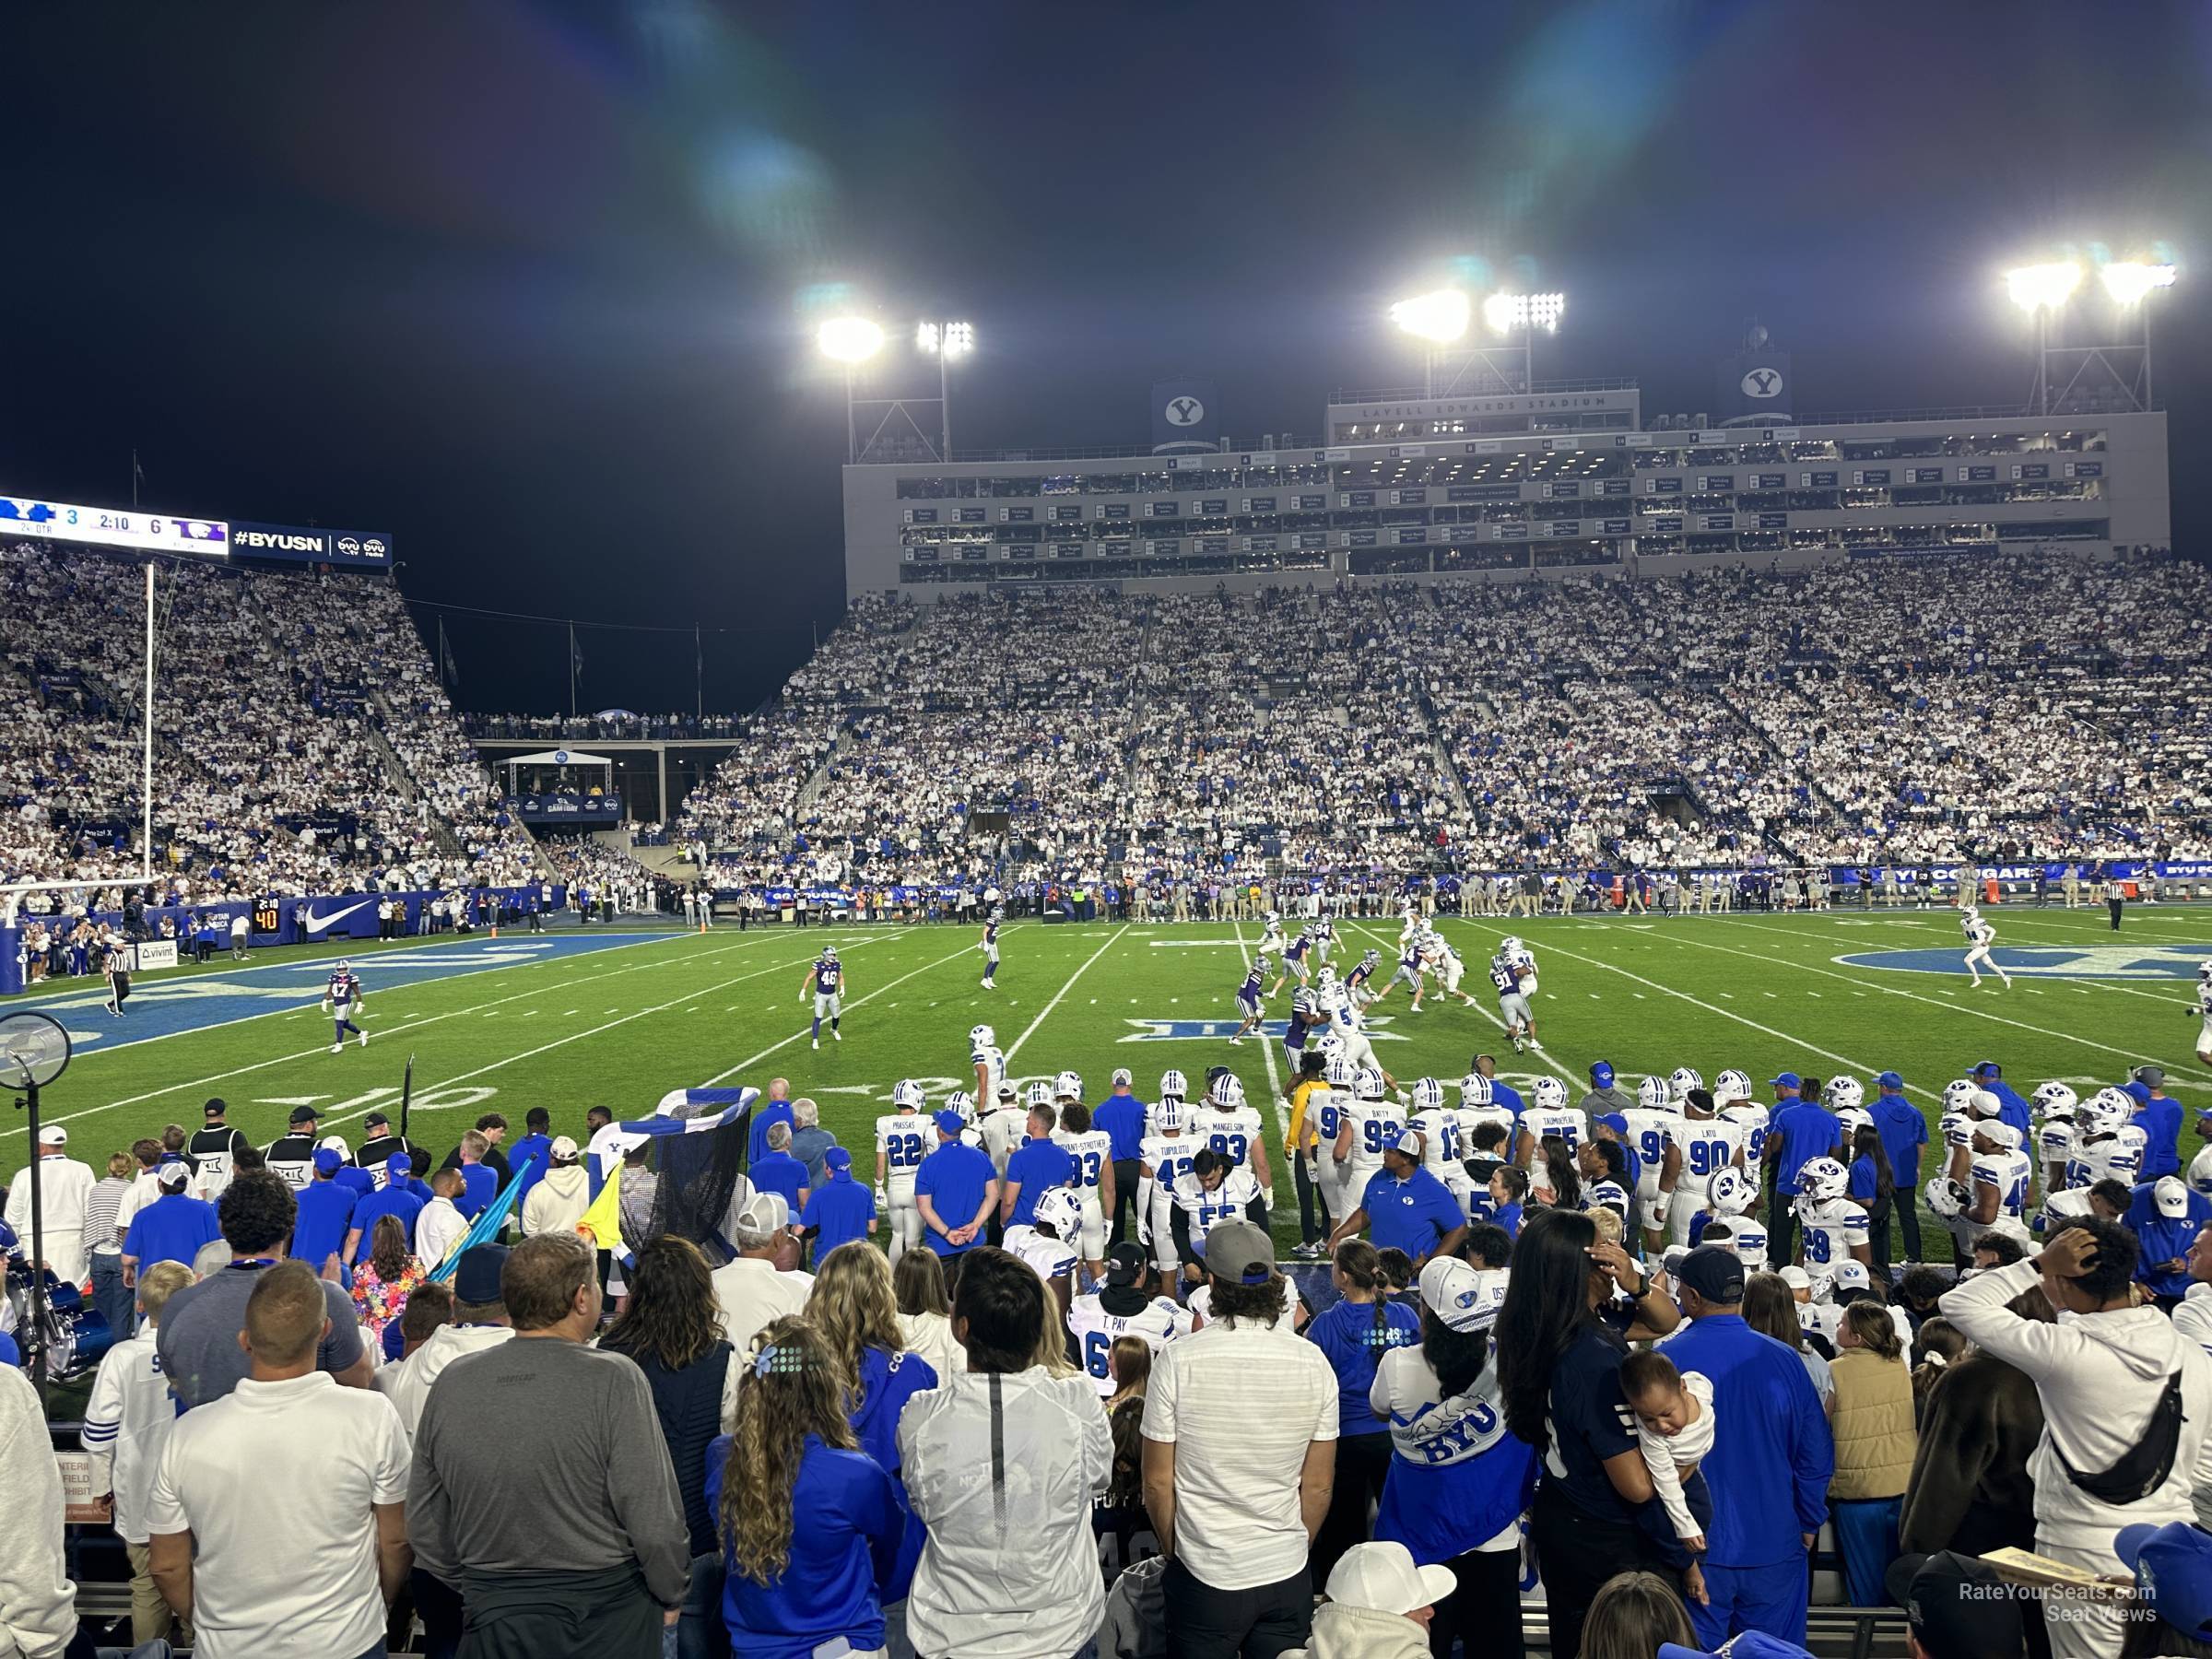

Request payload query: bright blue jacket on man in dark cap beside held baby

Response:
[1665,1314,1836,1566]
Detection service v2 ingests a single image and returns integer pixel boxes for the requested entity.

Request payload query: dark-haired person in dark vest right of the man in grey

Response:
[599,1237,743,1659]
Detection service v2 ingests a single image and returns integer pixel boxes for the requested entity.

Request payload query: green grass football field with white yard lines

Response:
[0,907,2212,1245]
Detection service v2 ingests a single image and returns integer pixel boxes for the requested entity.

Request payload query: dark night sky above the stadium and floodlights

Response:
[0,0,2212,710]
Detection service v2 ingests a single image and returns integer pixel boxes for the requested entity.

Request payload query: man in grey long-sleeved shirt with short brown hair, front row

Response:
[407,1232,690,1659]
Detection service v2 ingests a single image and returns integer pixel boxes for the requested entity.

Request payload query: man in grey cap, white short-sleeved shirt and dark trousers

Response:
[1141,1221,1338,1659]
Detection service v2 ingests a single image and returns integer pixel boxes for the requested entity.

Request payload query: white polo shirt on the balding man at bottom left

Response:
[146,1371,407,1659]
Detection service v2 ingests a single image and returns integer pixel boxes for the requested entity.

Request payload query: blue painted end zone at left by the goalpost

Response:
[6,931,684,1057]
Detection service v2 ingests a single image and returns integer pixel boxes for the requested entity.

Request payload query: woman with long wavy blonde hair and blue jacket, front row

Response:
[706,1318,907,1659]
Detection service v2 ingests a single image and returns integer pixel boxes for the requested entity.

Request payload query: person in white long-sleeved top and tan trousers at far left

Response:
[84,1261,193,1646]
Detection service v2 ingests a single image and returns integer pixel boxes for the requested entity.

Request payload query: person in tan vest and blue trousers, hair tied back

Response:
[1827,1300,1920,1608]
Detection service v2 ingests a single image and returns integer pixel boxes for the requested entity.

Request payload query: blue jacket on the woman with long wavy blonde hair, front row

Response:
[706,1433,907,1659]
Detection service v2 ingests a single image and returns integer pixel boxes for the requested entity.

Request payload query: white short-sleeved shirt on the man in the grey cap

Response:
[1144,1321,1336,1591]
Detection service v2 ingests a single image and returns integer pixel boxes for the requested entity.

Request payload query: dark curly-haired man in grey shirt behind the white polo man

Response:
[157,1171,376,1409]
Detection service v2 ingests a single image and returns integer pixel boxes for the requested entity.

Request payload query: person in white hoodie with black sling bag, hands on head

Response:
[1940,1218,2212,1659]
